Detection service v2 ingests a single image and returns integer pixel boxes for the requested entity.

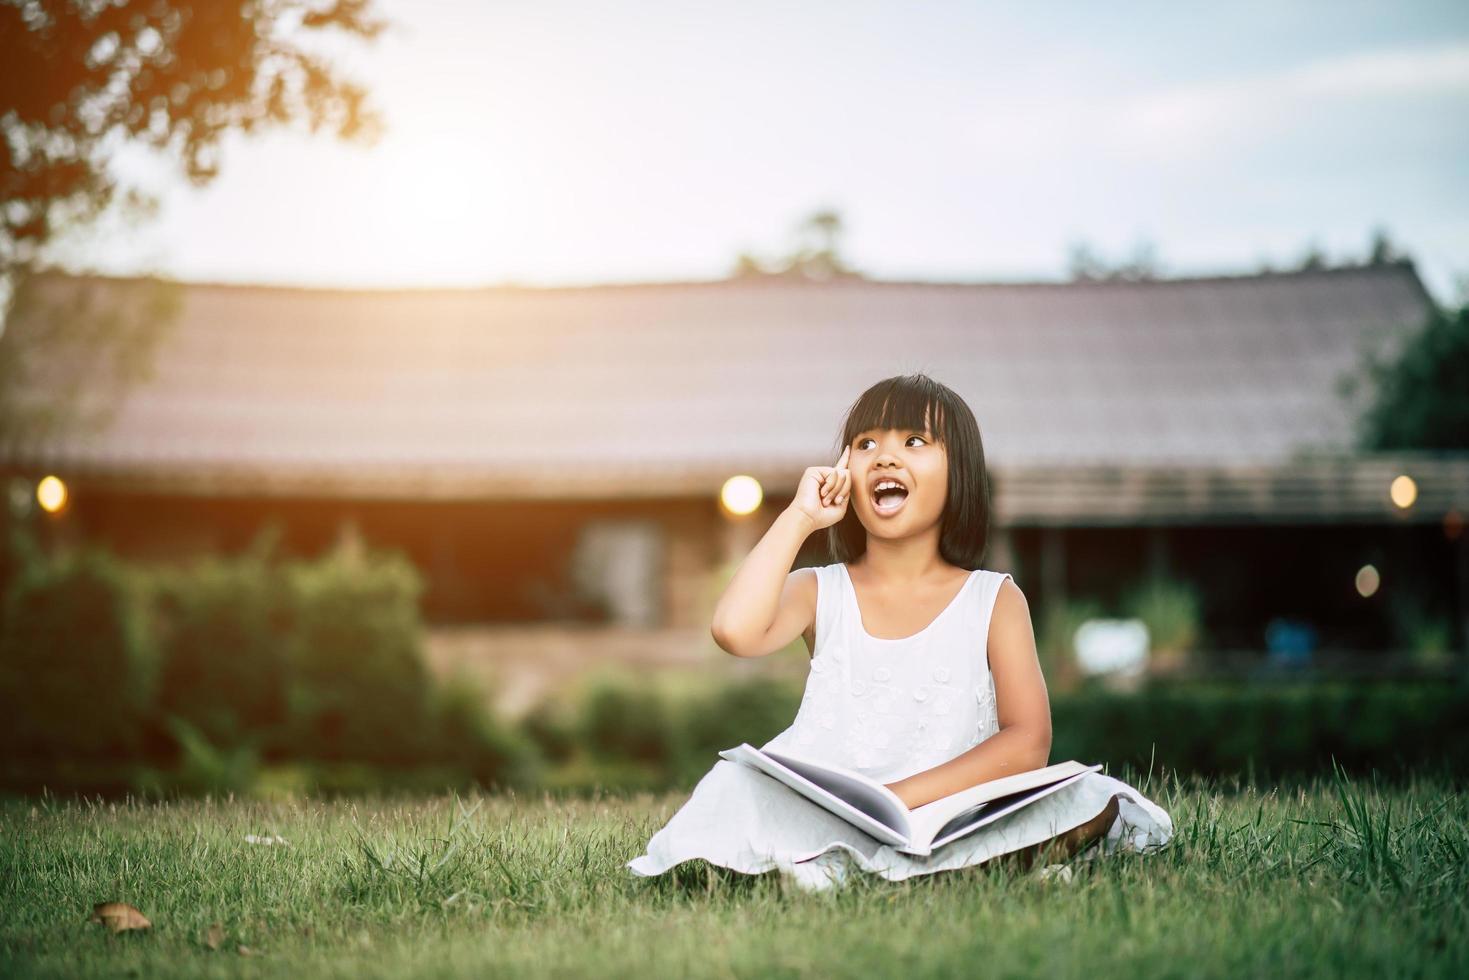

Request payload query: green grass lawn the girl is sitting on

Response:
[0,774,1469,977]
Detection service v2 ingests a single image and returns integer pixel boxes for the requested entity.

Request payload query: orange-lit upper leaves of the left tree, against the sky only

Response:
[0,0,386,270]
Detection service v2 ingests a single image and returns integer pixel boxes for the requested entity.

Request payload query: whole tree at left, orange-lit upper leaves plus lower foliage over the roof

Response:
[0,0,386,443]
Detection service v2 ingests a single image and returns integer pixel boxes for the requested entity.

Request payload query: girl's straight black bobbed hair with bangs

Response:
[827,375,990,572]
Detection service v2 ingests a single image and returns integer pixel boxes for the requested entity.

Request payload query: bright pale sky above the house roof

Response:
[45,0,1469,303]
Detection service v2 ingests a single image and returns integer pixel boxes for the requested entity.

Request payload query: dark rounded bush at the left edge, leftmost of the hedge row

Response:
[0,550,156,761]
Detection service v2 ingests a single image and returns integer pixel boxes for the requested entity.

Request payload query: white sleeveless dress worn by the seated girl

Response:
[627,564,1174,890]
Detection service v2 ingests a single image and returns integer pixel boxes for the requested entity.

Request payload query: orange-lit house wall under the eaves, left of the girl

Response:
[14,483,724,627]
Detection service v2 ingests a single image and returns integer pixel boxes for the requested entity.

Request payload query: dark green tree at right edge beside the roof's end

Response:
[1341,304,1469,450]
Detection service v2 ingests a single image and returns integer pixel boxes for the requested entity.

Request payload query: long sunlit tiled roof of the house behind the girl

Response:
[7,262,1457,520]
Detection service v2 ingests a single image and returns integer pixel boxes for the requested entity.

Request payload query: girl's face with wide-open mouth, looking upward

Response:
[848,429,949,538]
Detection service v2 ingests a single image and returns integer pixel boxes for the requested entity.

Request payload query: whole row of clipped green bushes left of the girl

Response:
[0,536,542,793]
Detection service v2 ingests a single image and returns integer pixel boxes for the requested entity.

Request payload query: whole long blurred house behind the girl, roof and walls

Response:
[0,262,1469,667]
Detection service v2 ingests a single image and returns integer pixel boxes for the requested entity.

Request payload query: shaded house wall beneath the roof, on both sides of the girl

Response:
[20,485,1469,651]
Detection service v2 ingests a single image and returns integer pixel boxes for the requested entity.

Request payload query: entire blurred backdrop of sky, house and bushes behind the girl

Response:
[0,0,1469,793]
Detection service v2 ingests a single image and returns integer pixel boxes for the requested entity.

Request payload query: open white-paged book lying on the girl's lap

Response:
[720,742,1102,857]
